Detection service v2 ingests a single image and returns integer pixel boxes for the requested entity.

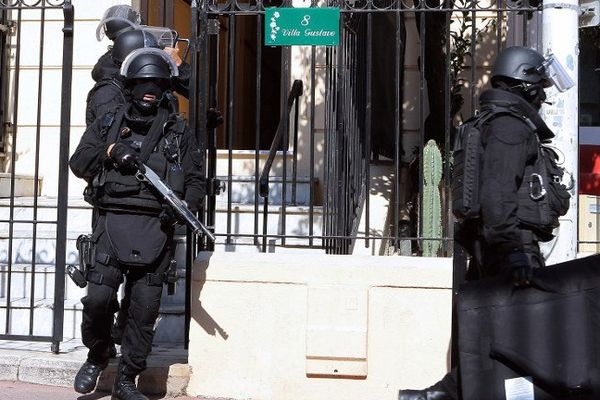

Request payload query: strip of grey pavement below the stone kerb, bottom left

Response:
[0,381,198,400]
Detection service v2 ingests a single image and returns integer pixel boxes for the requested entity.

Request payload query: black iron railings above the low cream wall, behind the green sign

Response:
[190,0,541,256]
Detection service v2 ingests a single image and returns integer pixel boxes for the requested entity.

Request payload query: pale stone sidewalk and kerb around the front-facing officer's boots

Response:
[0,340,192,400]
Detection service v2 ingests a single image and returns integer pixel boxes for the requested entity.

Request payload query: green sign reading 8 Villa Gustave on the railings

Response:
[265,7,340,46]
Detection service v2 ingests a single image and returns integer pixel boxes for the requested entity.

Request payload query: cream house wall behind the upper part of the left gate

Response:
[4,0,131,196]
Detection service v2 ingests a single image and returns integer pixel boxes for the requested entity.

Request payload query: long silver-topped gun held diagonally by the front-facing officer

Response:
[135,162,215,242]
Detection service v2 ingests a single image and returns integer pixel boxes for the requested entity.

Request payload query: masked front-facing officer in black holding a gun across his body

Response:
[69,48,205,400]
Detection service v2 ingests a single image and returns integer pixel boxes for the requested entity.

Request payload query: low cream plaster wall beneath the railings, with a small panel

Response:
[187,253,451,400]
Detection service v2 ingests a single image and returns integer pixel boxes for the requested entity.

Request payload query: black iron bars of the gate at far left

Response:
[0,0,74,352]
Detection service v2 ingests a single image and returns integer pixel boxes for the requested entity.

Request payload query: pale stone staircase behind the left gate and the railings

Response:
[0,177,323,347]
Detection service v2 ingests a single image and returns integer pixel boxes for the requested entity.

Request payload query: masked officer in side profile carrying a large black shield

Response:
[399,46,570,400]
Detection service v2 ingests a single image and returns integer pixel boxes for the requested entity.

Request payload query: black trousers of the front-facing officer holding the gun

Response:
[81,217,171,375]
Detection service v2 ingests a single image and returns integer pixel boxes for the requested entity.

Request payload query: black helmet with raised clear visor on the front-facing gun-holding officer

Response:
[121,47,179,80]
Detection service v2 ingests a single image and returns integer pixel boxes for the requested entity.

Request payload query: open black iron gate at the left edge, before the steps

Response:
[0,0,74,352]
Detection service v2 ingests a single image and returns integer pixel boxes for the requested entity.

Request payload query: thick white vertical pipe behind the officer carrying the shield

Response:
[541,0,580,264]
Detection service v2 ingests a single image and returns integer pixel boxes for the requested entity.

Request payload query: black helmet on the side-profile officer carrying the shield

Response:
[492,46,552,87]
